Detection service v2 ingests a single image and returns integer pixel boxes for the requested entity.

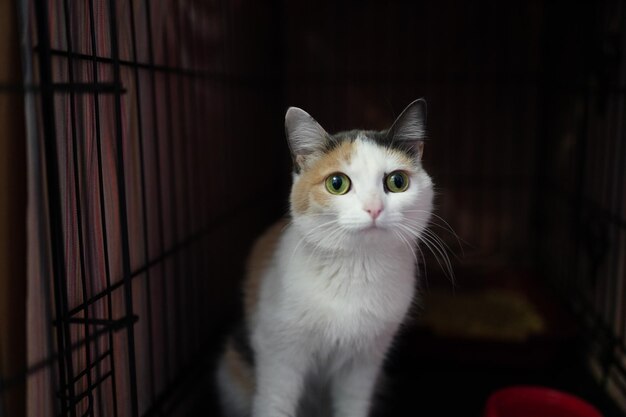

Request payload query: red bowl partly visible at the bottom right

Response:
[483,386,602,417]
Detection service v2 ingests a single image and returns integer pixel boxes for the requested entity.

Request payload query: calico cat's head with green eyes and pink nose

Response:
[285,99,433,249]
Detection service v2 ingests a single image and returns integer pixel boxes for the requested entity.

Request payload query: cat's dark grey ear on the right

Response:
[387,98,426,160]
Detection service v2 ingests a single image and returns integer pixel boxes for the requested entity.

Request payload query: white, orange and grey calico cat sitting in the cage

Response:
[217,99,433,417]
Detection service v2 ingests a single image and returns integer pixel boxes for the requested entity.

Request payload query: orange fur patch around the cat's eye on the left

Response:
[291,141,354,213]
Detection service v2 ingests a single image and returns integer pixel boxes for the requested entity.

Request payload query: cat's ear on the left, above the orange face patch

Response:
[285,107,329,172]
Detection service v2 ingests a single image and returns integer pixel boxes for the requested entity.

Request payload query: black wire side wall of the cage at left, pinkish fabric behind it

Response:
[13,0,285,416]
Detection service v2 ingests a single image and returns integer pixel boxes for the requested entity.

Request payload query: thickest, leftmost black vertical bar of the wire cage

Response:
[35,0,76,417]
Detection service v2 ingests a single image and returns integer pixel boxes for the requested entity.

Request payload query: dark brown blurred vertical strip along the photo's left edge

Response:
[0,1,27,416]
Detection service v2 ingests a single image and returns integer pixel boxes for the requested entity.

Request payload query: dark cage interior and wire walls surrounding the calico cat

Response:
[0,0,626,417]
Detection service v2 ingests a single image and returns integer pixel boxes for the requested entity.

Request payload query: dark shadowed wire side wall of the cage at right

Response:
[537,1,626,409]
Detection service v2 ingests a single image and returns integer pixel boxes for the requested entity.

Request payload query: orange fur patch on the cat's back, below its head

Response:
[243,219,288,317]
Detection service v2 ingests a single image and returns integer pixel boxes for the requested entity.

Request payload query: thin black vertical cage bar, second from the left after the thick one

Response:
[63,0,93,412]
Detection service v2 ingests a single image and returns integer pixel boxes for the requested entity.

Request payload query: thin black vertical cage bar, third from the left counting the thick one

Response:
[89,0,118,417]
